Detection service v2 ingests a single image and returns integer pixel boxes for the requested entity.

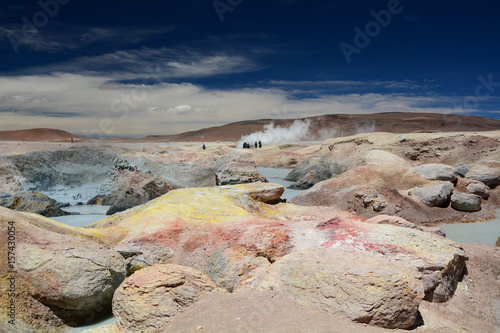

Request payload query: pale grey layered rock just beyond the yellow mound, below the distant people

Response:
[215,151,267,185]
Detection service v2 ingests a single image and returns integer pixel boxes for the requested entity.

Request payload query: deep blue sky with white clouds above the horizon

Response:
[0,0,500,136]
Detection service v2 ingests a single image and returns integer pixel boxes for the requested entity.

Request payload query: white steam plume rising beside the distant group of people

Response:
[236,120,311,148]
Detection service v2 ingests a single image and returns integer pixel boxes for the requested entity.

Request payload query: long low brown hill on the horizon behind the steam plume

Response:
[145,112,500,142]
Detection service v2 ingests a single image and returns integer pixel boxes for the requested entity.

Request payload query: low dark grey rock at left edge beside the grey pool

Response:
[0,191,70,217]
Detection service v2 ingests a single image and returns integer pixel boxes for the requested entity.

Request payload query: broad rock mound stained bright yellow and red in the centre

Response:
[90,183,467,327]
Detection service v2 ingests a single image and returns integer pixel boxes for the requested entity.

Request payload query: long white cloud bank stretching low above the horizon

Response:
[0,74,476,136]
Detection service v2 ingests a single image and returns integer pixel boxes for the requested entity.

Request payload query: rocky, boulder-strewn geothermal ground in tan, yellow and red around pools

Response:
[0,115,500,332]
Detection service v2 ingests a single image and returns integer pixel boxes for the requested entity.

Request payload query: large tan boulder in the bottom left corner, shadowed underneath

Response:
[0,207,125,332]
